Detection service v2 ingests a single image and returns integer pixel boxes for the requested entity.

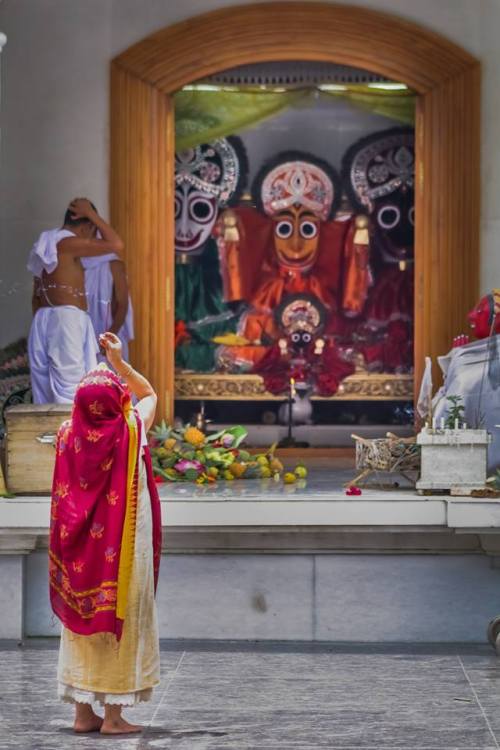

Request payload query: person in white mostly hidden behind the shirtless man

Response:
[82,253,134,360]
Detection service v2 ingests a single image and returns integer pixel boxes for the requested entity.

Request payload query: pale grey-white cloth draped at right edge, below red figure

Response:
[432,336,500,472]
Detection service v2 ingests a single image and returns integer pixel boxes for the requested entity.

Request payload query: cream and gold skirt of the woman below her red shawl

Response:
[57,460,160,706]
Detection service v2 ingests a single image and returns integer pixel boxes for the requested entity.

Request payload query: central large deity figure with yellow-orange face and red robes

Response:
[219,151,370,371]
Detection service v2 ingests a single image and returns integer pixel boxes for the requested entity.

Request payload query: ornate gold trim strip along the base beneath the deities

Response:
[175,372,413,401]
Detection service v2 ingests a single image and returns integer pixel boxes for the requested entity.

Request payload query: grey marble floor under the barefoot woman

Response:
[0,641,500,750]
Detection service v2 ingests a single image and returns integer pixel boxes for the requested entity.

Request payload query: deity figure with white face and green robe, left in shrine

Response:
[175,136,247,372]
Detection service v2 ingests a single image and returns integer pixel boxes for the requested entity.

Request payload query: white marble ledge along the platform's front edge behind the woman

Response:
[0,493,500,557]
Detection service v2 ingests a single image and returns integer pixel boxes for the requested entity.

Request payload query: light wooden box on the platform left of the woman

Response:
[5,404,72,495]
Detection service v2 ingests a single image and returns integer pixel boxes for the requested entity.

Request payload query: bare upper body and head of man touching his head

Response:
[33,198,123,312]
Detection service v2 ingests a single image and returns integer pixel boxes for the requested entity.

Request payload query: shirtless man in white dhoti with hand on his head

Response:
[28,198,124,404]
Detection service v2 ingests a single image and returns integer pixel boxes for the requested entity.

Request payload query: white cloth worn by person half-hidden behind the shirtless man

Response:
[81,253,134,360]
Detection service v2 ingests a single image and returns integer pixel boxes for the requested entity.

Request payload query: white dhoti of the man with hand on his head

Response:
[28,305,99,404]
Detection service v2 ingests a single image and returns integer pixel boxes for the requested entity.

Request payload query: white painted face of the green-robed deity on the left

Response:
[175,184,218,253]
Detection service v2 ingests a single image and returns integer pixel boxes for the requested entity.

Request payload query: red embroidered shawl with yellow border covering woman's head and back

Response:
[49,367,161,639]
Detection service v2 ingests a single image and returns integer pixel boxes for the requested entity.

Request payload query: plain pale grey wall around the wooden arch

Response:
[0,0,500,346]
